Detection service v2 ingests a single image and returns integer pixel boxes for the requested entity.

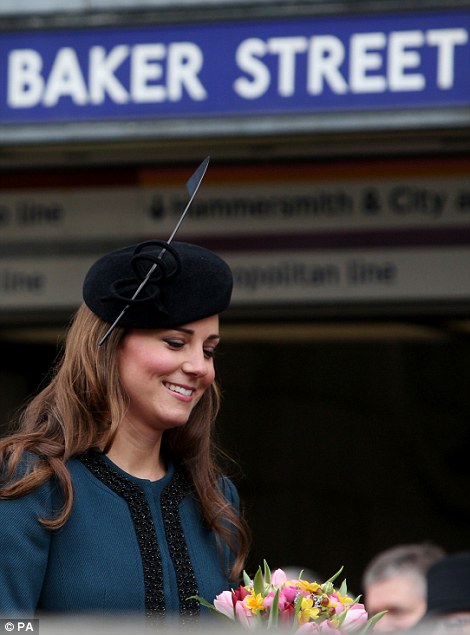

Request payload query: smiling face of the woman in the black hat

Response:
[118,315,219,431]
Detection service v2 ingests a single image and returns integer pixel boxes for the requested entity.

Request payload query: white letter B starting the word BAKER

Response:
[7,49,44,108]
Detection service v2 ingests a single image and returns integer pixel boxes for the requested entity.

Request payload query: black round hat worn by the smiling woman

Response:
[83,240,233,329]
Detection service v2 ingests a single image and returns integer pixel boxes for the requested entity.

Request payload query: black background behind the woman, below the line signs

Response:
[0,332,470,593]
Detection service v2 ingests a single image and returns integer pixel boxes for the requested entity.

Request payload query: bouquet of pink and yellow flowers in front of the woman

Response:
[193,561,383,635]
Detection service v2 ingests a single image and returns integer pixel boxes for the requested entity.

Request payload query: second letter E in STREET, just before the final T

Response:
[388,31,426,91]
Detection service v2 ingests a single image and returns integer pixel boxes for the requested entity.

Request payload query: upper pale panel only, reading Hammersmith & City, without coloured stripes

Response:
[0,176,470,241]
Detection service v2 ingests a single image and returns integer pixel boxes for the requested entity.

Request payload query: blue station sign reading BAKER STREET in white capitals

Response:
[0,11,470,124]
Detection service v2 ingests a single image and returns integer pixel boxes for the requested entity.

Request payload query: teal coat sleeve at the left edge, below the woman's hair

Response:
[0,483,52,617]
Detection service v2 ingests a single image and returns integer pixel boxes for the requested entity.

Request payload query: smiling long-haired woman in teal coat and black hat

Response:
[0,241,248,619]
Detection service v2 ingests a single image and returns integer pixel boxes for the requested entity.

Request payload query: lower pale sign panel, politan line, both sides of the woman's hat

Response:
[0,249,470,309]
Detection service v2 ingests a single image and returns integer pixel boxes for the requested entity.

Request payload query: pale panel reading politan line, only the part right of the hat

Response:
[228,249,470,304]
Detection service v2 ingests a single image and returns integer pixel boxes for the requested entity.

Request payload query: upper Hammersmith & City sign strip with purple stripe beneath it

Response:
[0,175,470,242]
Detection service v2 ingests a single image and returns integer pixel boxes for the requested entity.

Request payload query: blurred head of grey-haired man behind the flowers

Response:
[362,544,445,632]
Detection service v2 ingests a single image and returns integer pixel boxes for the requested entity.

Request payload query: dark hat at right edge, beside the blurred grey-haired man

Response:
[426,551,470,616]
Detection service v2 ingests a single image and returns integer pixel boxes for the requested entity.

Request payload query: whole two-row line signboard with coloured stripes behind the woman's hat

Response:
[0,162,470,311]
